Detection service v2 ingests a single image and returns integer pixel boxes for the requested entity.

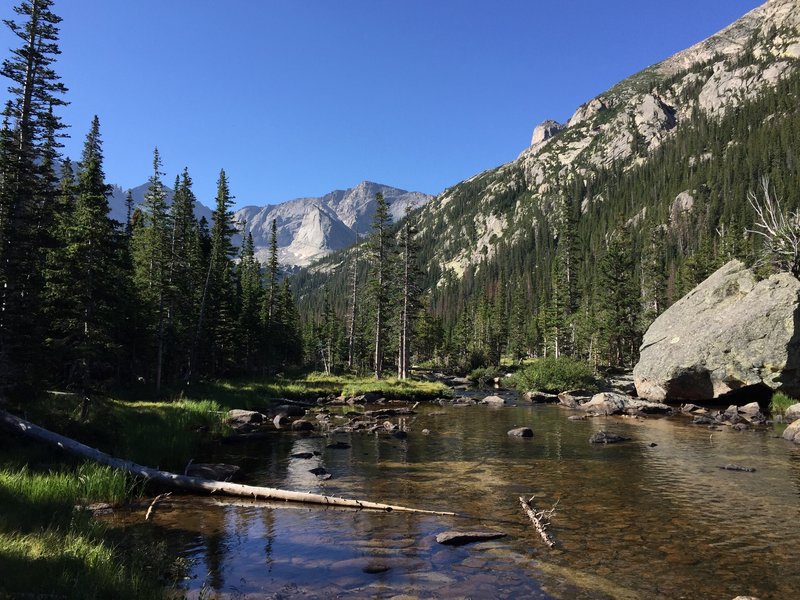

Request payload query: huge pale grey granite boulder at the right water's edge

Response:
[633,260,800,402]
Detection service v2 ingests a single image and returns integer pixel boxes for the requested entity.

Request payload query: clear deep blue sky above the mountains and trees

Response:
[0,0,760,206]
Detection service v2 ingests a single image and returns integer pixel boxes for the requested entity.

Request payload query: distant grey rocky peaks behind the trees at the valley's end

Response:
[109,181,432,266]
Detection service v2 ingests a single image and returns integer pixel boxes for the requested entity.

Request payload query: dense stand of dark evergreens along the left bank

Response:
[0,0,302,404]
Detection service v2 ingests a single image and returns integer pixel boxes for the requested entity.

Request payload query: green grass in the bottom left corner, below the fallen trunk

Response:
[0,464,167,598]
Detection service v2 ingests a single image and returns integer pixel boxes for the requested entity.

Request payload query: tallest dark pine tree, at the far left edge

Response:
[0,0,66,393]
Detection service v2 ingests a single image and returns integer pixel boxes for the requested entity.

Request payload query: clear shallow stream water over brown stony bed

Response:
[104,404,800,600]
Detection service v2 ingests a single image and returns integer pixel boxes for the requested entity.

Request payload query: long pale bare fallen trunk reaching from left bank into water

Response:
[0,410,458,517]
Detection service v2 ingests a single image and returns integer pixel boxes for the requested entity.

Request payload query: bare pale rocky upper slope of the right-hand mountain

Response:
[420,0,800,276]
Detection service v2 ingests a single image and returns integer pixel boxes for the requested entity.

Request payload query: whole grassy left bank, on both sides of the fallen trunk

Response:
[0,373,449,598]
